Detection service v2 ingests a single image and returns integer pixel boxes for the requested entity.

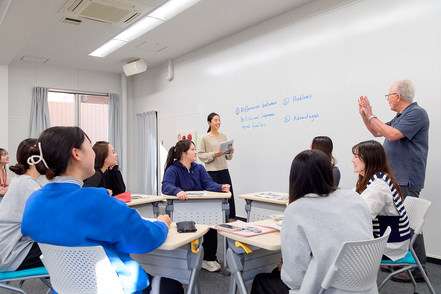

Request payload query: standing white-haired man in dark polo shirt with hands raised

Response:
[358,80,429,282]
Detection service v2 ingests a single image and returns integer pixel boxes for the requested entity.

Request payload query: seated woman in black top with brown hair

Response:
[84,141,126,196]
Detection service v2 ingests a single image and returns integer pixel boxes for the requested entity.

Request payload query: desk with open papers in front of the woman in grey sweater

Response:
[218,220,282,294]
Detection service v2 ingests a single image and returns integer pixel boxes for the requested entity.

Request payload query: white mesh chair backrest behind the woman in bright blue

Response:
[38,243,124,294]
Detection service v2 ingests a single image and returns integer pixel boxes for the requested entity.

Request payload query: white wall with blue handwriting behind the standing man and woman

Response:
[129,0,441,258]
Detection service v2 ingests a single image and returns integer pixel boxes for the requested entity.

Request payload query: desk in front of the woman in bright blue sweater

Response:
[130,222,209,294]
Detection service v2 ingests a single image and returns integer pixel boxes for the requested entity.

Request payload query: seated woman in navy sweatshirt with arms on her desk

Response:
[162,140,230,272]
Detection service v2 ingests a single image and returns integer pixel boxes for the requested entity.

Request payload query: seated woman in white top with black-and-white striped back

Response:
[352,140,410,261]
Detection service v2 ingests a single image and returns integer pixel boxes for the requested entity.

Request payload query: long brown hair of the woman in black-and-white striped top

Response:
[352,140,403,199]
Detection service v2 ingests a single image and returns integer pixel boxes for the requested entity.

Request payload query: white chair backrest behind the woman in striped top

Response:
[404,196,432,234]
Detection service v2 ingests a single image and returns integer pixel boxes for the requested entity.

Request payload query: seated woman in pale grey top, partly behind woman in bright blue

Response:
[0,139,43,272]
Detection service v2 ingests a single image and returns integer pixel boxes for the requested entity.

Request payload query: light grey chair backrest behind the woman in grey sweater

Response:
[320,227,391,293]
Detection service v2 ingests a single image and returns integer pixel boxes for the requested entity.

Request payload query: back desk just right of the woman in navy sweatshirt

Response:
[239,191,288,222]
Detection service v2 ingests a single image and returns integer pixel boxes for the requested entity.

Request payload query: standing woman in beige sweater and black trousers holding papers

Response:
[198,112,236,219]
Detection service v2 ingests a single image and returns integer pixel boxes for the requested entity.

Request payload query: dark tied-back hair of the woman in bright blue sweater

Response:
[34,127,90,180]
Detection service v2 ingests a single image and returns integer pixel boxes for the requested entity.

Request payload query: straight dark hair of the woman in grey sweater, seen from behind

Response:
[289,150,337,203]
